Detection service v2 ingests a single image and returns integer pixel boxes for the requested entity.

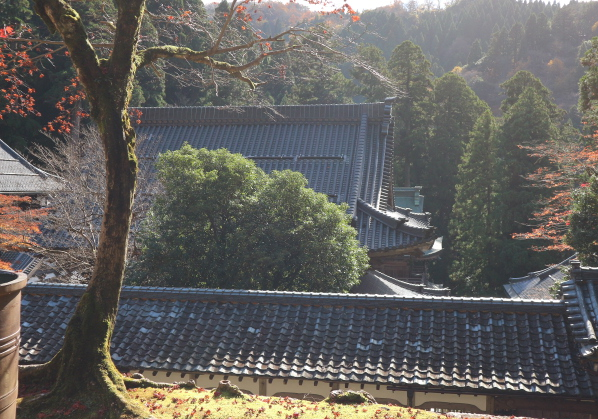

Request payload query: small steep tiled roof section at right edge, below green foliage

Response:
[561,261,598,362]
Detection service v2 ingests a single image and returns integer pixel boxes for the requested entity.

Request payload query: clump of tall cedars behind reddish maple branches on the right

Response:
[449,71,562,295]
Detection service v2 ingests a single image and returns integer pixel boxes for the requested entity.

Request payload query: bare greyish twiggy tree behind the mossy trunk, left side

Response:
[32,127,158,279]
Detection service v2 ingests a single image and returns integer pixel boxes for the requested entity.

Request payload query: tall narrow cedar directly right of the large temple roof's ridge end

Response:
[388,41,433,186]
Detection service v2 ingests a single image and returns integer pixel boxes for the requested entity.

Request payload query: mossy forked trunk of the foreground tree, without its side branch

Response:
[23,0,144,412]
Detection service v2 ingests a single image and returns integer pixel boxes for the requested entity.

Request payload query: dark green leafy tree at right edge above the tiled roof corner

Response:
[565,173,598,266]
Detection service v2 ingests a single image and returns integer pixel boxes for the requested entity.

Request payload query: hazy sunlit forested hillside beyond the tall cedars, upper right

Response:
[354,0,598,110]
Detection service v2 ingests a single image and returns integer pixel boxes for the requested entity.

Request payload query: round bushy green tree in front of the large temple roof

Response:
[127,144,368,292]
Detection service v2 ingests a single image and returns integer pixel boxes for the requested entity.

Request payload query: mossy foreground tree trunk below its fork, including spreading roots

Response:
[19,110,147,418]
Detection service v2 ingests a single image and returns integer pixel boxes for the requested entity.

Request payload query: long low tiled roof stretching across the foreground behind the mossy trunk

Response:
[20,284,596,397]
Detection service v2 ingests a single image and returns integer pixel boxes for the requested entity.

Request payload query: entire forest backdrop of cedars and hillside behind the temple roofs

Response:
[0,0,598,295]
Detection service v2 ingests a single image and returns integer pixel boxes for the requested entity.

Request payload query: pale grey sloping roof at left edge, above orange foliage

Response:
[0,140,56,195]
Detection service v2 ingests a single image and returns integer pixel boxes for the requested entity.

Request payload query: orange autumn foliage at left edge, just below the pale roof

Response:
[0,195,47,269]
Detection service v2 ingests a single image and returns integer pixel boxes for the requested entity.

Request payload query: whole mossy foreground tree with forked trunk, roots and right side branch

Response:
[9,0,354,418]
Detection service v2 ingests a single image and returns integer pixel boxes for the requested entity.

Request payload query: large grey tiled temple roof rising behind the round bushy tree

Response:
[137,98,433,250]
